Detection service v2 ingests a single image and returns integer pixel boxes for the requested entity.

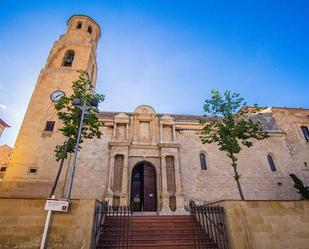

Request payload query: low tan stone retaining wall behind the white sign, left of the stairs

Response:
[0,198,95,249]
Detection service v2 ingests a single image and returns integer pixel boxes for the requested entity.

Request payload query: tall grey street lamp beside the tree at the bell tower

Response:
[66,97,99,200]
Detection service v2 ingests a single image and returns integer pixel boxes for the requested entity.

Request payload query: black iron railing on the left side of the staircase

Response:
[93,201,132,249]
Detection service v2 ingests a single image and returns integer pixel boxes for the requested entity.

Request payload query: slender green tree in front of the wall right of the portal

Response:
[200,90,268,200]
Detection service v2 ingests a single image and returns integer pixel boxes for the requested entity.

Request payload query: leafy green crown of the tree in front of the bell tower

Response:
[55,70,104,161]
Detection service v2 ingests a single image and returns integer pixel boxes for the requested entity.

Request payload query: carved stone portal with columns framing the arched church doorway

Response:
[106,105,185,214]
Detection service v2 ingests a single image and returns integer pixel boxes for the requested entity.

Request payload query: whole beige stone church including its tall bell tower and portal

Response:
[0,15,309,214]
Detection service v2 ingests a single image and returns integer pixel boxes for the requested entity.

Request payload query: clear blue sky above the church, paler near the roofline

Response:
[0,0,309,146]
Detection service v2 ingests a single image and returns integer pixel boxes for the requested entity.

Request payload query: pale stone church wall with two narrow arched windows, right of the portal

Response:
[177,126,309,202]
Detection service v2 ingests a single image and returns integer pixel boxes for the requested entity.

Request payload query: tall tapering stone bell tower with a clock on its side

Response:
[0,15,101,198]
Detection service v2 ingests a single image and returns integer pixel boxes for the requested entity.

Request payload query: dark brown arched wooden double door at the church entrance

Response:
[130,162,157,212]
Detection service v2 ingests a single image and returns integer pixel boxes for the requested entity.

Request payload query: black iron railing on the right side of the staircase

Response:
[190,201,229,249]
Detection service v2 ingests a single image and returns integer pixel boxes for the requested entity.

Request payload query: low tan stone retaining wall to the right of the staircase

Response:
[216,201,309,249]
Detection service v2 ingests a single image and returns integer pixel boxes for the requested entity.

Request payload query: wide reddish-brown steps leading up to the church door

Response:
[97,215,217,249]
